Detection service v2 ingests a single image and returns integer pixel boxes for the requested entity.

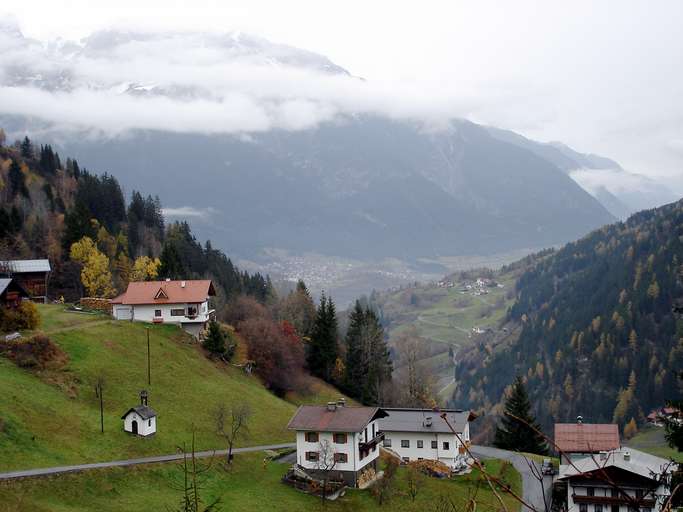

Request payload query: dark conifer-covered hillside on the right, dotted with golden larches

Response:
[454,201,683,427]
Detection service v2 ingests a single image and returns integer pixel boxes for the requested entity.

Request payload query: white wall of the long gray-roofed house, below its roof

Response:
[383,424,470,467]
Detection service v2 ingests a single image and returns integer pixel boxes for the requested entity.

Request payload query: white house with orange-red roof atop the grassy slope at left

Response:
[111,279,216,337]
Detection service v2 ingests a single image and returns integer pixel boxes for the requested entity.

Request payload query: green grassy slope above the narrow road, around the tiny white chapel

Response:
[0,306,338,471]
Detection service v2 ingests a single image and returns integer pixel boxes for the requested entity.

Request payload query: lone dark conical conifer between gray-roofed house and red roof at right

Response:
[493,376,548,455]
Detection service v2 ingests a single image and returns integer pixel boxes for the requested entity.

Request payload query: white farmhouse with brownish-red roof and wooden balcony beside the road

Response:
[287,400,386,487]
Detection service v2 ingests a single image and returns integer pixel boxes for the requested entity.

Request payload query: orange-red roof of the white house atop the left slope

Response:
[111,279,216,304]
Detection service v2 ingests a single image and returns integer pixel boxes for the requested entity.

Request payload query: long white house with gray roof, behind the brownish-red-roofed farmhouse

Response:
[379,408,476,468]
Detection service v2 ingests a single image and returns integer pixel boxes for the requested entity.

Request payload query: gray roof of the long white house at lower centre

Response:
[379,408,475,434]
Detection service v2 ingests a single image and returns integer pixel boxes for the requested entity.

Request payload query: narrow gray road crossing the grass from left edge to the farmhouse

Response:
[0,443,296,480]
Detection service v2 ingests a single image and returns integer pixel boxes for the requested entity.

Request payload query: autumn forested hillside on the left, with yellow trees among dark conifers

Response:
[0,130,272,302]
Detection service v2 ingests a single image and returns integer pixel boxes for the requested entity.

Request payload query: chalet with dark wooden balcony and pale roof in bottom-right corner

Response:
[557,448,673,512]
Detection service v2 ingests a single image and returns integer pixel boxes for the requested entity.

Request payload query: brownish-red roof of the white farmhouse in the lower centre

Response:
[287,405,387,432]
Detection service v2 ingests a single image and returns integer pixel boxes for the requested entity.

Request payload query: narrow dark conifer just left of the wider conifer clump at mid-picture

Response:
[307,293,339,382]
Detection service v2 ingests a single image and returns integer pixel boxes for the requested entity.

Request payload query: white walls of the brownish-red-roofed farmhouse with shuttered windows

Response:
[296,420,379,472]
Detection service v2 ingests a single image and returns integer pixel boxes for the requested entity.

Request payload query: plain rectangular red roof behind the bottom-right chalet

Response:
[555,423,621,453]
